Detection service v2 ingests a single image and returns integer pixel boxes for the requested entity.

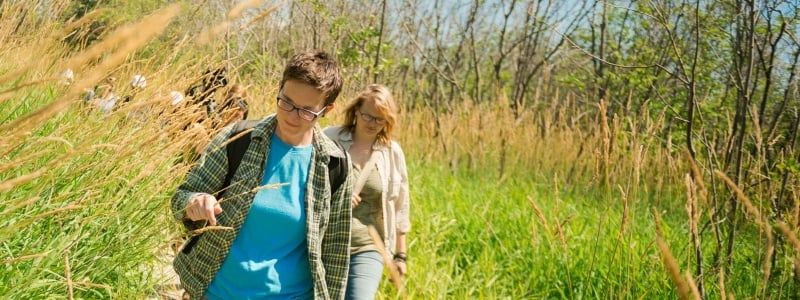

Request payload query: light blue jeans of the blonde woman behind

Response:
[344,251,383,300]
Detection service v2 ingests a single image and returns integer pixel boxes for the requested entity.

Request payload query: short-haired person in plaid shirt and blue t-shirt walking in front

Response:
[172,51,353,299]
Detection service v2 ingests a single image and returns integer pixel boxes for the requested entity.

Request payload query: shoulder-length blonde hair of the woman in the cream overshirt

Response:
[342,84,397,145]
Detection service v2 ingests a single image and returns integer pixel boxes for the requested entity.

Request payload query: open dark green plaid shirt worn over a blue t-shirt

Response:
[172,115,354,299]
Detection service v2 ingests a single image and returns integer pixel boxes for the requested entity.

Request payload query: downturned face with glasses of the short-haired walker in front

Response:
[276,80,333,146]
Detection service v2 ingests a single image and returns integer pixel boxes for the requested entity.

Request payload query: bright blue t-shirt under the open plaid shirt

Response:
[206,134,314,299]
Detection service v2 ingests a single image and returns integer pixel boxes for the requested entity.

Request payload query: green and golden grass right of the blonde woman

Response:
[374,99,793,299]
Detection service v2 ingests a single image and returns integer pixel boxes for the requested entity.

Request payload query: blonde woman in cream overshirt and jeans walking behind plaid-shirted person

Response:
[325,84,411,299]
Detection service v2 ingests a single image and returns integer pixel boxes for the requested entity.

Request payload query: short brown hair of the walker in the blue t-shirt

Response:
[281,50,343,105]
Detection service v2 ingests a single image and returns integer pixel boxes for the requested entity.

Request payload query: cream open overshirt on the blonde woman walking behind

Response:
[323,126,411,253]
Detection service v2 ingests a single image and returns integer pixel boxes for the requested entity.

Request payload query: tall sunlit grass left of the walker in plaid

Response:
[0,2,234,299]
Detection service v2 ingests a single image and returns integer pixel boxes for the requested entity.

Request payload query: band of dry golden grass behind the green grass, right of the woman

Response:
[397,88,684,197]
